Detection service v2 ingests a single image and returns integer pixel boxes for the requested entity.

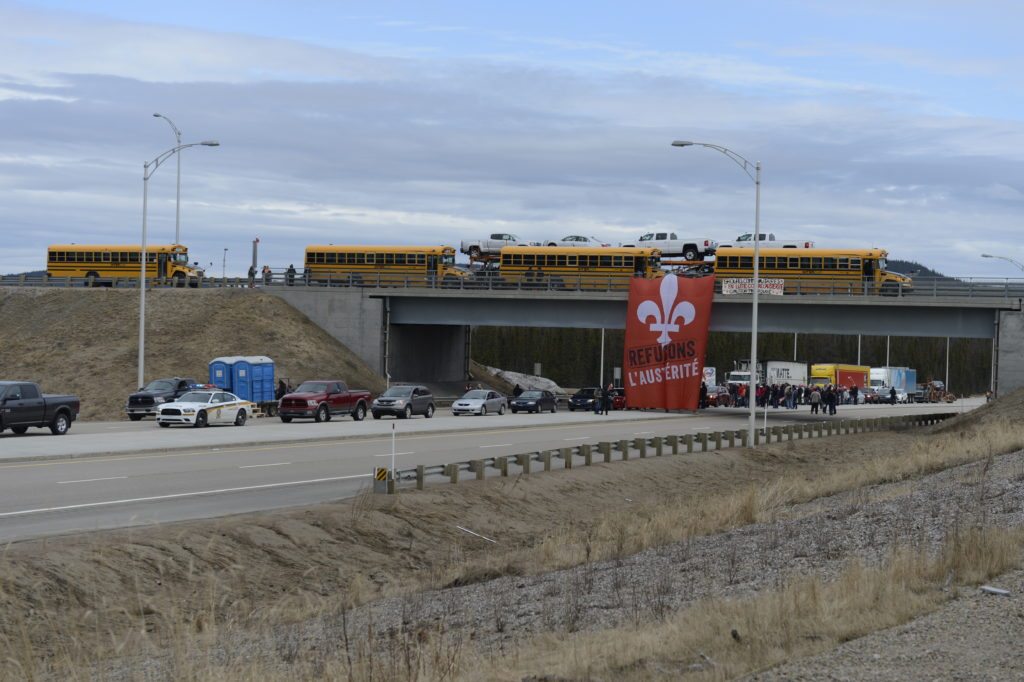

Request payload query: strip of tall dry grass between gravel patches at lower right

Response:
[479,528,1024,680]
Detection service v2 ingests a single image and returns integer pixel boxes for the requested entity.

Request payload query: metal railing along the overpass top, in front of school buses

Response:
[6,270,1024,300]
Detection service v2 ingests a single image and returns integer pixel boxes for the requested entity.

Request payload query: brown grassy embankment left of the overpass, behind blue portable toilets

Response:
[0,288,384,419]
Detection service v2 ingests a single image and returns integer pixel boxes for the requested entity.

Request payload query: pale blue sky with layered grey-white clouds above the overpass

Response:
[0,0,1024,278]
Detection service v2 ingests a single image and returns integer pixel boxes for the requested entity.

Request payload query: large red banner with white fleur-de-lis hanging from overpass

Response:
[623,274,715,410]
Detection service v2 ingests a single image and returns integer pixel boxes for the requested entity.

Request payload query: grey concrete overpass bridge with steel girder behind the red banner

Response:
[264,282,1024,399]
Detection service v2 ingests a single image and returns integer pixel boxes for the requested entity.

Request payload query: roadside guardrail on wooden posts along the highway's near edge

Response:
[382,413,957,494]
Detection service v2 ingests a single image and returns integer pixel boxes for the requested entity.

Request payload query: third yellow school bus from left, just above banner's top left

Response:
[499,246,665,289]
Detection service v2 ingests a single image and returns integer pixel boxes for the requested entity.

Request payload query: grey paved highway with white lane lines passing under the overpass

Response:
[0,399,981,542]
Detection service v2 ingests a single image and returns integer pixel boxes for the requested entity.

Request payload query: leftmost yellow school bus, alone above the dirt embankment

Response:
[46,244,203,286]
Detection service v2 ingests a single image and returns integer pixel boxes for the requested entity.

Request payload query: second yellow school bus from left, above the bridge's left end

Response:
[304,245,468,287]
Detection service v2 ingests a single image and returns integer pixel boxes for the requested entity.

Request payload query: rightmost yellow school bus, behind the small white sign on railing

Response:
[715,248,913,296]
